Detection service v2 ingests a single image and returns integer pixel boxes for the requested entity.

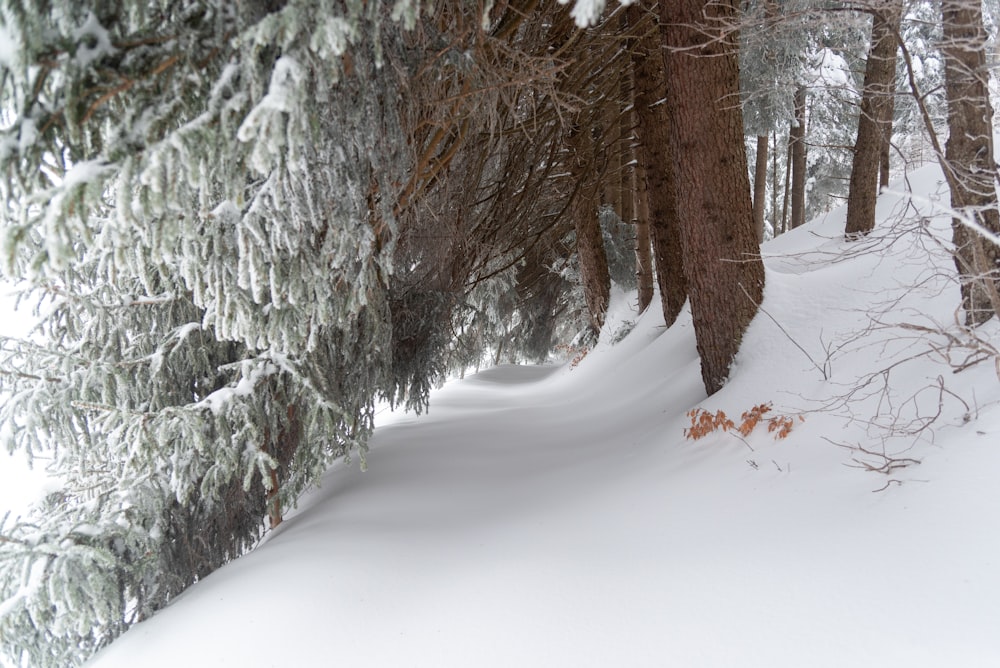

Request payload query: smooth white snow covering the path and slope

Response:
[54,168,1000,668]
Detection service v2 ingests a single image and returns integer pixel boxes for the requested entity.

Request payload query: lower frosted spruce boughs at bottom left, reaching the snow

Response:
[0,270,386,666]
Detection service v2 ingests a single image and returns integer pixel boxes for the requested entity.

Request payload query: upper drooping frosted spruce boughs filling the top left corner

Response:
[0,2,405,351]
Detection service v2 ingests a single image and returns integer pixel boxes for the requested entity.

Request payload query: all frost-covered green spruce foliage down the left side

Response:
[0,0,410,668]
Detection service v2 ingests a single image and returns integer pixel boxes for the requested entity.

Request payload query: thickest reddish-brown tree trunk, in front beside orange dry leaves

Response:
[660,0,764,394]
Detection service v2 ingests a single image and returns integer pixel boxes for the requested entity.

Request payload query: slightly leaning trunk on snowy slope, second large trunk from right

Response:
[845,0,903,236]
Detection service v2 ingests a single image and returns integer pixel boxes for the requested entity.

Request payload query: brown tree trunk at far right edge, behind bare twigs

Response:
[941,0,1000,326]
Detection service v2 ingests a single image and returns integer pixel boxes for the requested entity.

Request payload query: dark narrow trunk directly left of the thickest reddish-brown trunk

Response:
[628,3,687,327]
